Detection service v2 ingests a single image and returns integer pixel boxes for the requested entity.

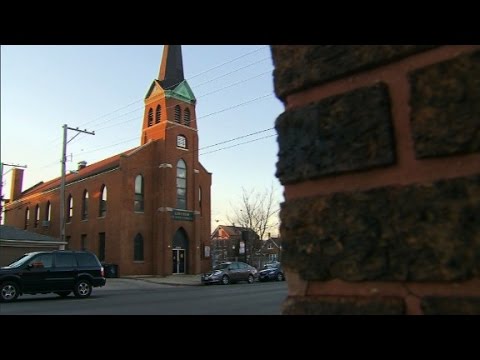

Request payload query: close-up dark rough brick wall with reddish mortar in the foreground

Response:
[271,45,480,314]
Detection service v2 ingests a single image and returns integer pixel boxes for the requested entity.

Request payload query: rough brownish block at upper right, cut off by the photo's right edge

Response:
[409,51,480,159]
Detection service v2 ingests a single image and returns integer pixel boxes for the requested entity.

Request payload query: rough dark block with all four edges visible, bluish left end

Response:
[275,83,395,184]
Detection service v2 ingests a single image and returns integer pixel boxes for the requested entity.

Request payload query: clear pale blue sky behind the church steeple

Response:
[1,45,283,231]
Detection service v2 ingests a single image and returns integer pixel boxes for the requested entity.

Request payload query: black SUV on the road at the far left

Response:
[0,250,106,302]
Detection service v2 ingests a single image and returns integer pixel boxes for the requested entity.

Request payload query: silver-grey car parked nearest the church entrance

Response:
[201,261,258,285]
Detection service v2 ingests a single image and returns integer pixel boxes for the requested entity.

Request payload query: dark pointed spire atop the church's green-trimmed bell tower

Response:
[158,45,185,90]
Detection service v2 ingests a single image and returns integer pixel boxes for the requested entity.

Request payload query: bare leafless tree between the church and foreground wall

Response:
[227,184,279,250]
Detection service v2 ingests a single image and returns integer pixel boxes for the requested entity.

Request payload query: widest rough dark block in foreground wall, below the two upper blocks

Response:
[280,175,480,281]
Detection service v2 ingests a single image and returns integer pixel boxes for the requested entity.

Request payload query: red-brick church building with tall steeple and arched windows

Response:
[5,45,212,276]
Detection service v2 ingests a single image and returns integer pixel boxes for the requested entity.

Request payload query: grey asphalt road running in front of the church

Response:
[0,279,287,315]
